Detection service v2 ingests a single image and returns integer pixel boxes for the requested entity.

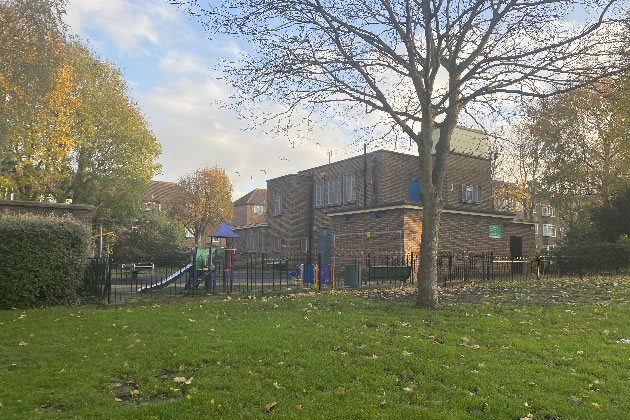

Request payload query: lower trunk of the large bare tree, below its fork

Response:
[416,199,441,308]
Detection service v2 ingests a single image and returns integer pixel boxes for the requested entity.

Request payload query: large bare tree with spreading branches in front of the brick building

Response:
[171,0,623,307]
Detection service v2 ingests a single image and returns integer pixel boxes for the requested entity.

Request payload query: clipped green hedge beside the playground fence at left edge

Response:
[0,215,90,309]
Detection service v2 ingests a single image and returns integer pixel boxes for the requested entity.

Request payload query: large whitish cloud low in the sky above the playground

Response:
[140,69,356,197]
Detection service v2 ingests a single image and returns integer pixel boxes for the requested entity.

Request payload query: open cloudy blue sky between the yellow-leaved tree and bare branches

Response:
[65,0,372,199]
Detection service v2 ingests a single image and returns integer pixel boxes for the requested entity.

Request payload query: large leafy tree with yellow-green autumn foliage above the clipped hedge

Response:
[0,0,161,225]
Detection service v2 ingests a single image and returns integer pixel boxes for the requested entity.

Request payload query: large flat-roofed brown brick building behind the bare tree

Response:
[235,128,535,261]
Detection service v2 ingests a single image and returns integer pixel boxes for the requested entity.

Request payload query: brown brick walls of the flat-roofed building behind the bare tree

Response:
[261,151,534,255]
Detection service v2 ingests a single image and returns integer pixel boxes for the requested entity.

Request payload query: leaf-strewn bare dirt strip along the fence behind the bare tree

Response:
[341,276,630,306]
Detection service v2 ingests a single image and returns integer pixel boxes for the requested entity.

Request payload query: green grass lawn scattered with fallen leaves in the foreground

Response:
[0,278,630,419]
